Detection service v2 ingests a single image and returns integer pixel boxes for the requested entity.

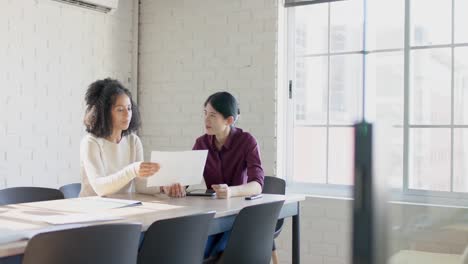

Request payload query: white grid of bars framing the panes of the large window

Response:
[286,0,468,201]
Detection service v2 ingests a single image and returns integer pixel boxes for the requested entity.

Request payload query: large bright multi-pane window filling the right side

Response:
[288,0,468,196]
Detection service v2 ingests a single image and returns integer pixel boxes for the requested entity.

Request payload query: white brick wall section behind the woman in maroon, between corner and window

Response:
[138,0,278,175]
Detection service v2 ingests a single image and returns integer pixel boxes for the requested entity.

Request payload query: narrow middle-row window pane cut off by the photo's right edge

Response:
[454,47,468,125]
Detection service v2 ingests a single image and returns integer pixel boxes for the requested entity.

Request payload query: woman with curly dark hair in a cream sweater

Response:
[80,78,180,197]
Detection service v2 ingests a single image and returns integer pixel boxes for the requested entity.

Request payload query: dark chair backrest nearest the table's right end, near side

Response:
[219,201,284,264]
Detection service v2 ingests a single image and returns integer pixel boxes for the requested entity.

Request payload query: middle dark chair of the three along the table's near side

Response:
[138,212,215,264]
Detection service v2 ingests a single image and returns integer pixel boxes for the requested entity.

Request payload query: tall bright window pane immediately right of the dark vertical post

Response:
[366,52,404,189]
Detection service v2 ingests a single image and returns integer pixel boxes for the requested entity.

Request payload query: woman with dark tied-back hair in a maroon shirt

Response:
[168,92,264,259]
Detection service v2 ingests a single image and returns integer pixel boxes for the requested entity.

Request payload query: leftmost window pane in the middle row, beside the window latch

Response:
[294,57,328,125]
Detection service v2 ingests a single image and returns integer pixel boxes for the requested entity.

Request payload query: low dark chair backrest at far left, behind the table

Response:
[0,187,63,205]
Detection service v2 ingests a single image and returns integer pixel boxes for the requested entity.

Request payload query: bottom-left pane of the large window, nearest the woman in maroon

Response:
[293,127,327,183]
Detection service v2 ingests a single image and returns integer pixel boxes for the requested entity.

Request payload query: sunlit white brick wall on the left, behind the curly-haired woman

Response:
[0,0,133,188]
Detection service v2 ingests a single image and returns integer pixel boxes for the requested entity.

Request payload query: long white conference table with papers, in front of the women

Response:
[0,194,305,263]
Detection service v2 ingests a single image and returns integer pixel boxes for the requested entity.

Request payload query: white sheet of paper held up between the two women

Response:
[147,150,208,187]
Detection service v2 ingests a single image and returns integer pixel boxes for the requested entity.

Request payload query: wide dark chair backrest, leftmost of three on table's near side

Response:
[22,224,141,264]
